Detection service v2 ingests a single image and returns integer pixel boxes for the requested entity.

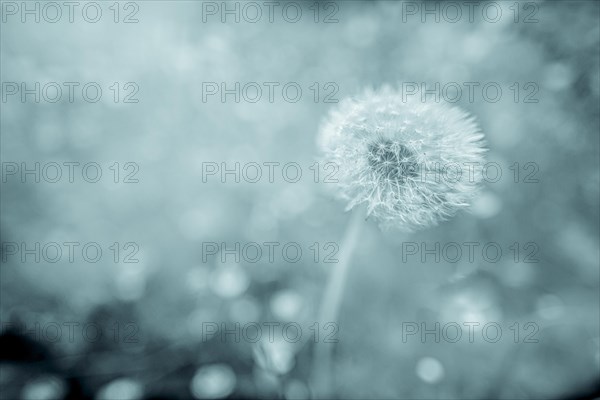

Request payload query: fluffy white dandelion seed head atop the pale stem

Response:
[318,88,486,231]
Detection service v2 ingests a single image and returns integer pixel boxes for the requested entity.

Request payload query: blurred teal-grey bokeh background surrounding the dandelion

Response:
[0,0,600,399]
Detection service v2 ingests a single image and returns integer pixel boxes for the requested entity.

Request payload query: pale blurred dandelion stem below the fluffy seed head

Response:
[311,207,366,399]
